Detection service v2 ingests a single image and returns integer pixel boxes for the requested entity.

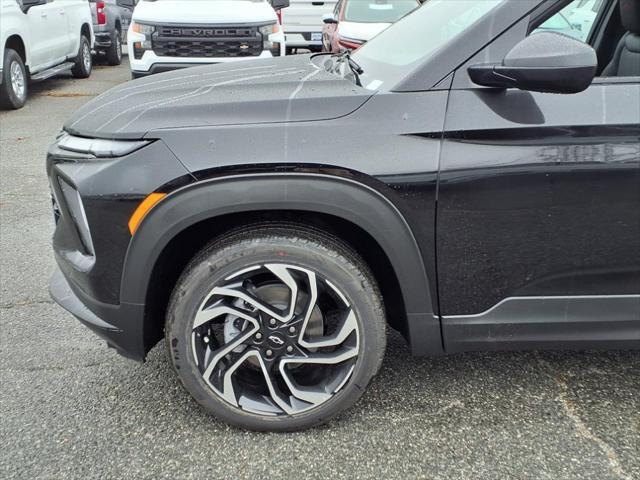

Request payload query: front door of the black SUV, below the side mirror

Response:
[436,0,640,351]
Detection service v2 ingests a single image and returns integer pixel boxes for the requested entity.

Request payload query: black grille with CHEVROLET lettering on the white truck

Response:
[152,26,263,58]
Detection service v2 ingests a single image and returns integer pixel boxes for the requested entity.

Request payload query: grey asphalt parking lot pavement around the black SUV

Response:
[0,58,640,480]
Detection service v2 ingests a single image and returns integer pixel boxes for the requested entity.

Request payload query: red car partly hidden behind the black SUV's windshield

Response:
[322,0,421,53]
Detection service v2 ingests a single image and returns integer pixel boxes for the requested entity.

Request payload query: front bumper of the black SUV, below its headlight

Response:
[47,135,188,360]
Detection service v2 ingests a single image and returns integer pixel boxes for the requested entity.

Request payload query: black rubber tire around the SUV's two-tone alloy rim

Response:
[165,224,386,431]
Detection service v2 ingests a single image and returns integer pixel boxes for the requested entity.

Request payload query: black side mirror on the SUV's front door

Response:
[467,32,598,93]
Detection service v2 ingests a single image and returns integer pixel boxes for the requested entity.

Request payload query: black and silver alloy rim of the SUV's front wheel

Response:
[191,263,360,416]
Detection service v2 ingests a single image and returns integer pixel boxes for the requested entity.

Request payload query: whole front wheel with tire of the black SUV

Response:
[165,225,386,431]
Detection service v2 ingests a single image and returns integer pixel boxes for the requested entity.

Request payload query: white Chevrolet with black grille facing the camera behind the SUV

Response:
[127,0,289,78]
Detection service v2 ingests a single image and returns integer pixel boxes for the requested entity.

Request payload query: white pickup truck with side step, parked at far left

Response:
[0,0,93,109]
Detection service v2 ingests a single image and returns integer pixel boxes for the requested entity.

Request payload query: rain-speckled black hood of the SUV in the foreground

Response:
[64,55,373,139]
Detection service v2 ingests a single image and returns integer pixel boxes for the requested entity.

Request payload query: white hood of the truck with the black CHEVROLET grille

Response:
[133,0,277,25]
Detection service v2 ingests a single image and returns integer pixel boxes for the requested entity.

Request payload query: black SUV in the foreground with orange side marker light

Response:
[47,0,640,430]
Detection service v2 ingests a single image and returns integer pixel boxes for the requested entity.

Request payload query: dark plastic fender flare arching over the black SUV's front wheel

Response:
[120,173,443,355]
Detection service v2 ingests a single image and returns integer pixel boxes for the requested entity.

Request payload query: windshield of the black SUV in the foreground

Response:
[353,0,507,90]
